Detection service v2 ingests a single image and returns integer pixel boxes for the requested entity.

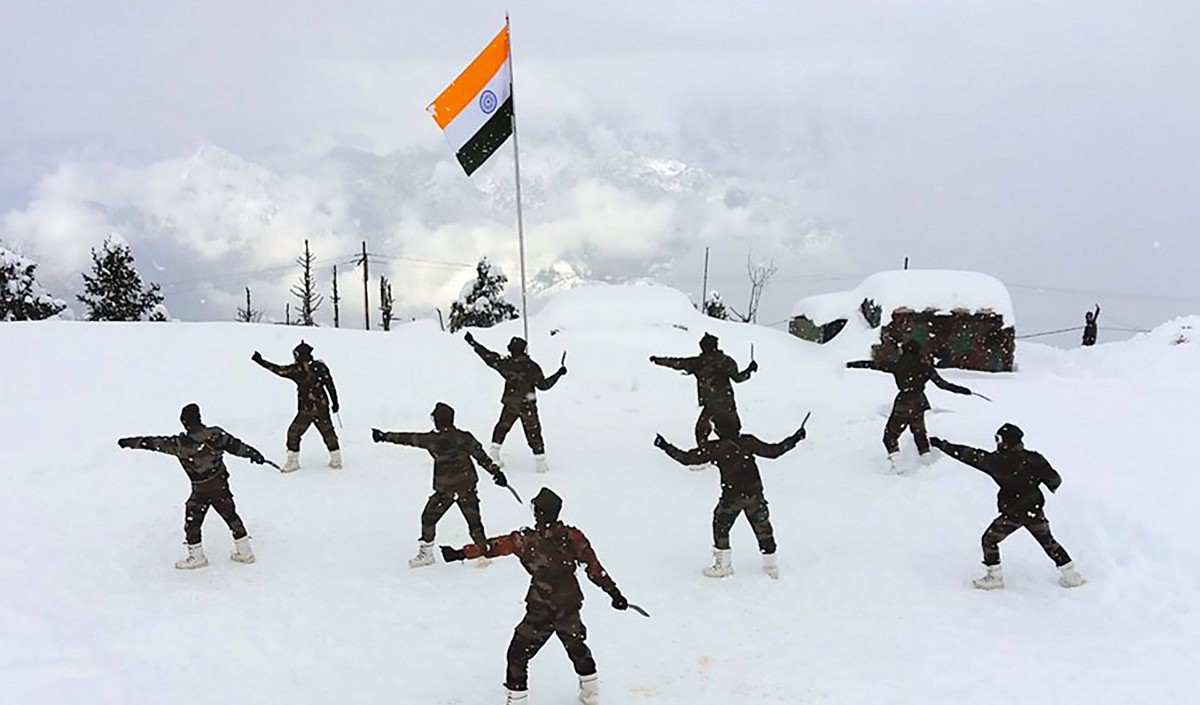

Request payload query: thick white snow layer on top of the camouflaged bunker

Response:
[792,270,1016,327]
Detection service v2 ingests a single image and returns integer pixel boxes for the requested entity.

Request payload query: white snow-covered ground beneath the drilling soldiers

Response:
[0,287,1200,705]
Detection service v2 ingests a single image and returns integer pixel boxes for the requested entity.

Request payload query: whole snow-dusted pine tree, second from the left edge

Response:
[76,233,166,320]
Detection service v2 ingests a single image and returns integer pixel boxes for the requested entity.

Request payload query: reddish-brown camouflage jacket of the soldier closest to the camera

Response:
[462,522,618,609]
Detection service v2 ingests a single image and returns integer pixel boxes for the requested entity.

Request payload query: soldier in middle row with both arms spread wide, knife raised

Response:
[654,411,806,579]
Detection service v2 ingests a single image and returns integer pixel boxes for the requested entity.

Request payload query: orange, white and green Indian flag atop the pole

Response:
[426,26,512,176]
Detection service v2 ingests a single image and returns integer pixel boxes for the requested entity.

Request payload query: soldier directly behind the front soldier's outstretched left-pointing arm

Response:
[371,402,509,568]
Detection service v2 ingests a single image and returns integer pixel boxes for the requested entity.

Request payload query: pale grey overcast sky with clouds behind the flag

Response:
[0,0,1200,344]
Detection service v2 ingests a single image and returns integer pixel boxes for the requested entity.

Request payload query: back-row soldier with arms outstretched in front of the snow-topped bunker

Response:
[846,341,971,466]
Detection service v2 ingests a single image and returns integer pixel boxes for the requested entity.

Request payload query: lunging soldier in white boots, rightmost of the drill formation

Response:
[930,423,1086,590]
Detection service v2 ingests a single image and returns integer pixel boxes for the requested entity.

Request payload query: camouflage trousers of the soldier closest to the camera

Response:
[504,602,596,691]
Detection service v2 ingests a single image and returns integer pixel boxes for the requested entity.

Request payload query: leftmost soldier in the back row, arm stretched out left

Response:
[251,341,342,472]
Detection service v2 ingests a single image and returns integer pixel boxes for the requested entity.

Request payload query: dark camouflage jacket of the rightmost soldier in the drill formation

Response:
[937,440,1062,516]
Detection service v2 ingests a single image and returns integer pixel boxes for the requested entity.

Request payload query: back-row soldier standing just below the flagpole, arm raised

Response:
[463,332,566,472]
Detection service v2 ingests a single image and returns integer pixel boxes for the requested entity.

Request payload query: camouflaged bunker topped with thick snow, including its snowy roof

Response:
[788,270,1016,372]
